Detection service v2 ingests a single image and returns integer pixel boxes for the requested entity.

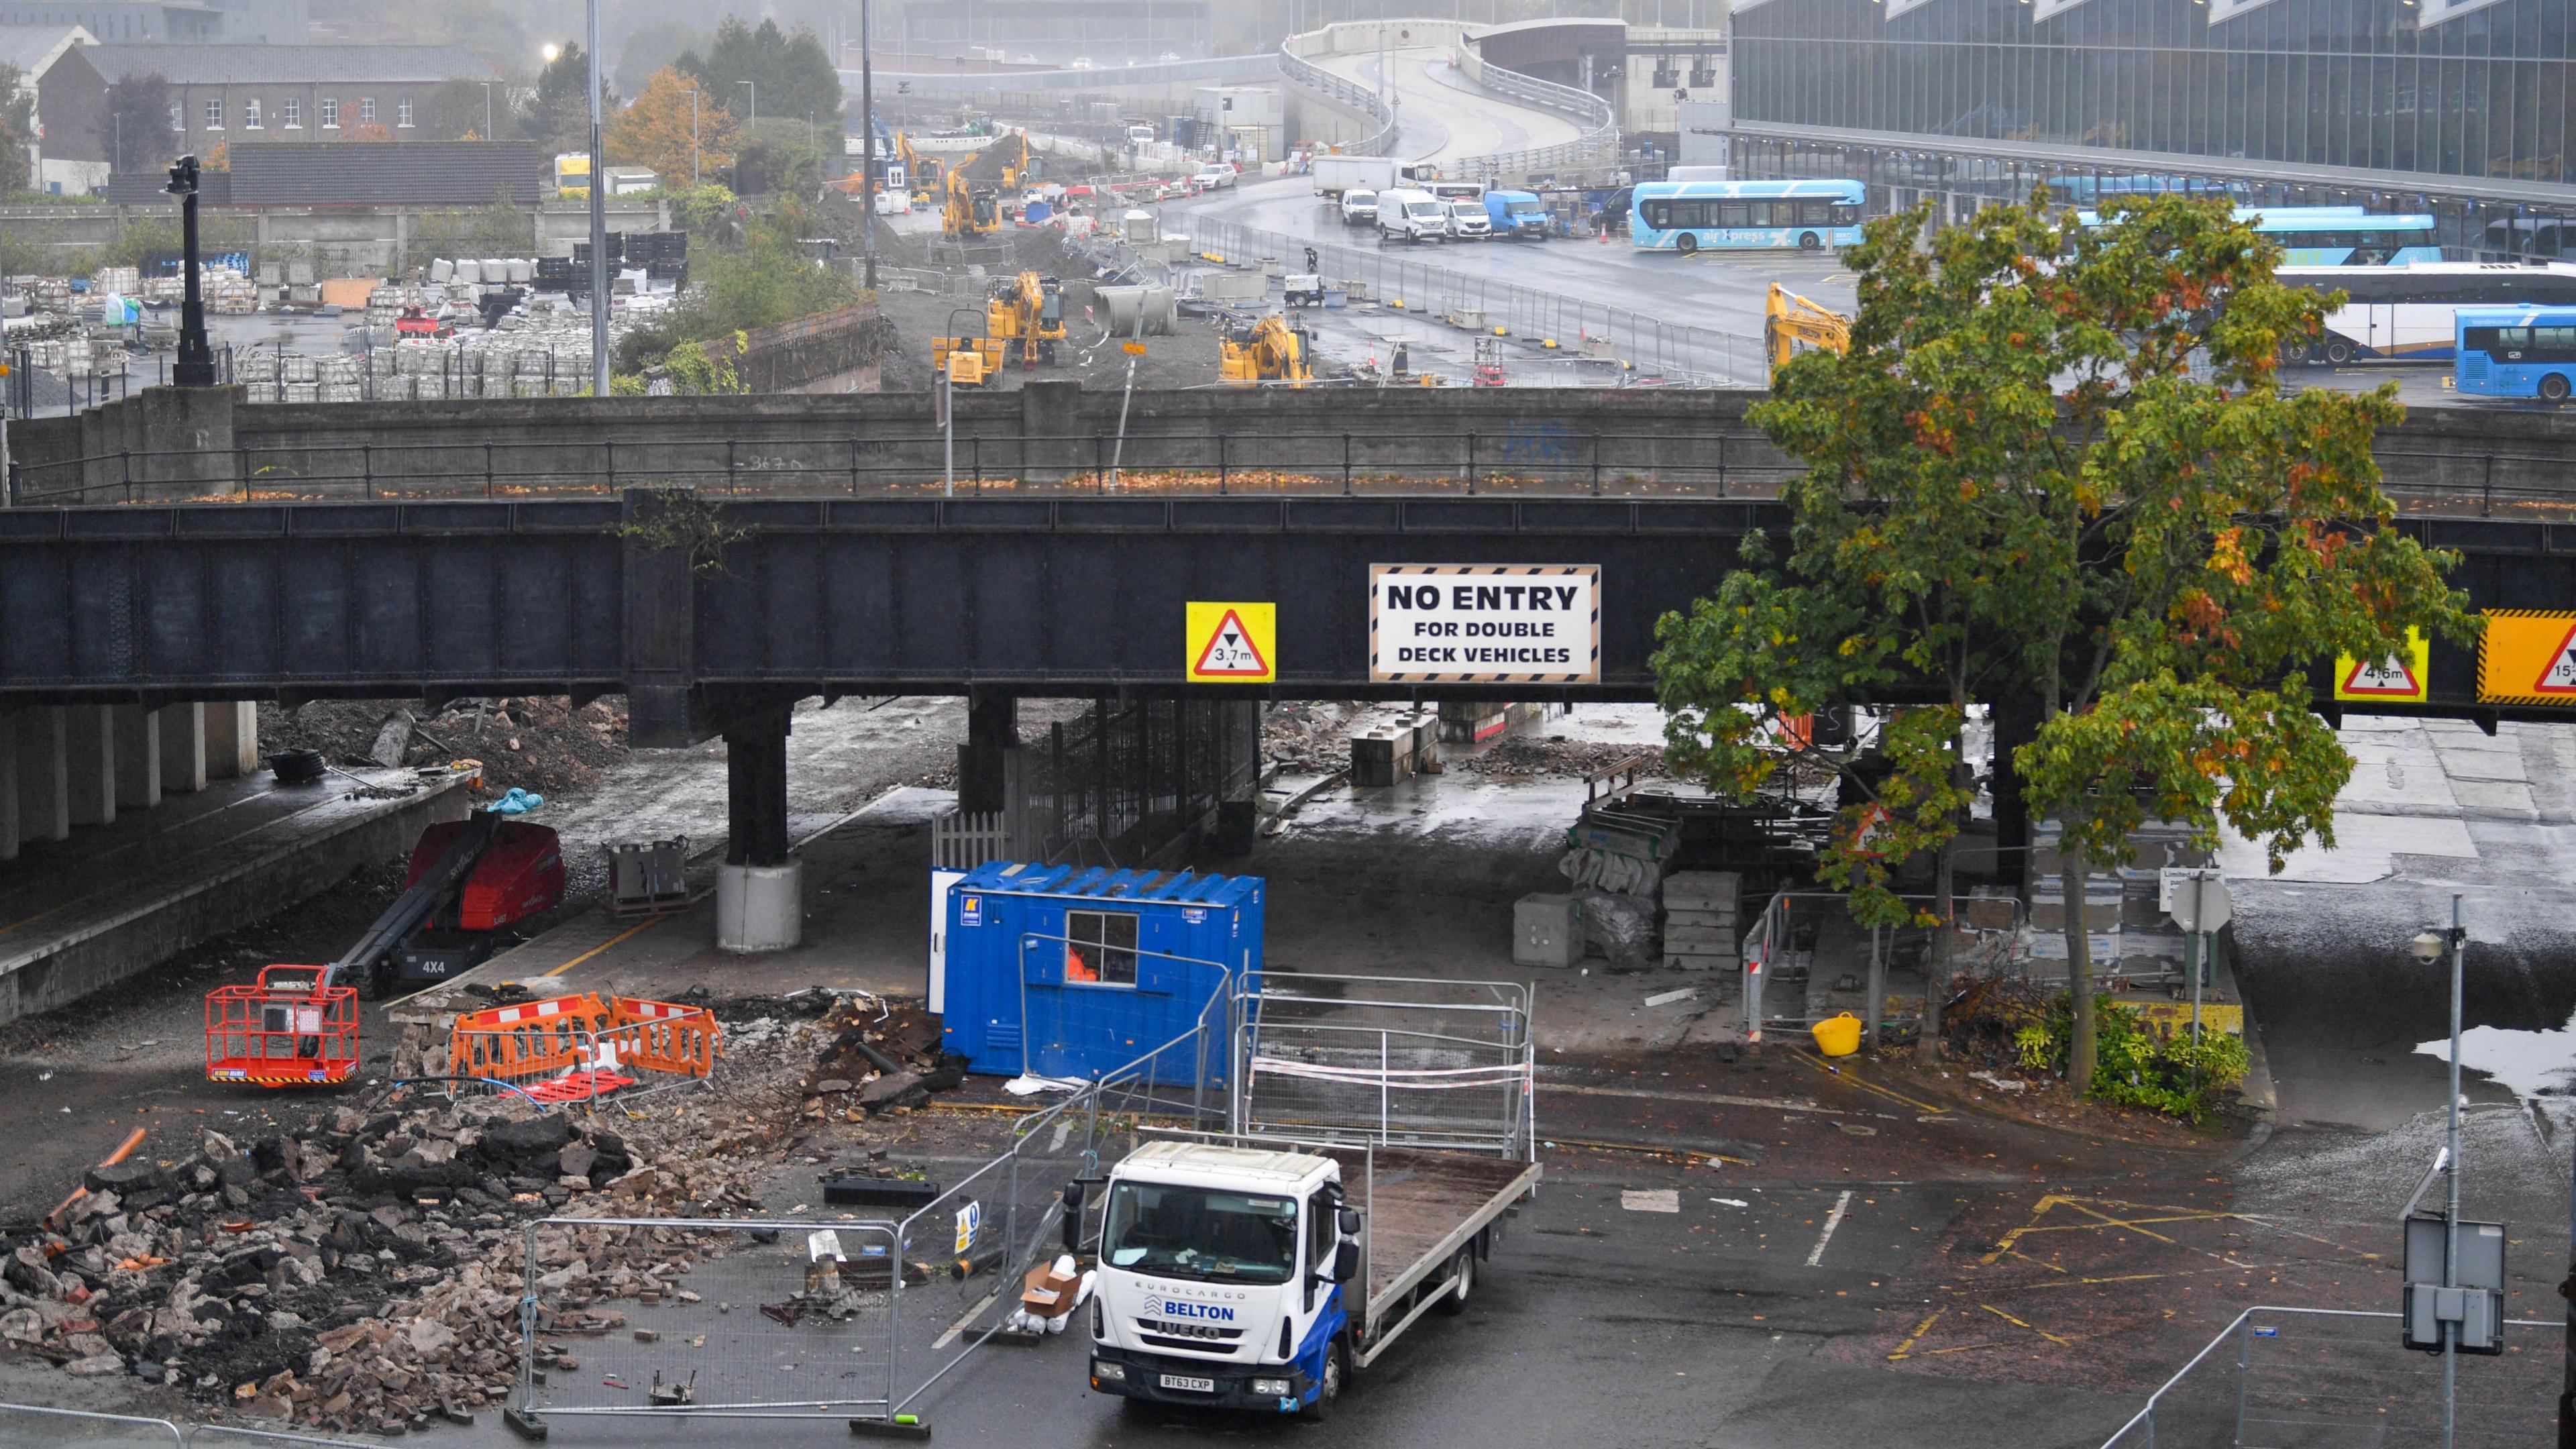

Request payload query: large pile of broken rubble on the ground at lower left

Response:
[0,1011,850,1434]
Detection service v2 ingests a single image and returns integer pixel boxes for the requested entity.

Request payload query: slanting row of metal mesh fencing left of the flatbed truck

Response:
[889,1010,1234,1413]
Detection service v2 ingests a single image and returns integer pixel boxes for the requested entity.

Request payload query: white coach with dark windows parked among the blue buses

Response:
[2275,260,2576,366]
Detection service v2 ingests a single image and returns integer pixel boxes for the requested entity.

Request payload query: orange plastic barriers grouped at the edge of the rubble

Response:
[448,993,724,1104]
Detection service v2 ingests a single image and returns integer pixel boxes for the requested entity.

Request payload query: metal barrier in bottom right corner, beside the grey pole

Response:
[2102,1307,2566,1449]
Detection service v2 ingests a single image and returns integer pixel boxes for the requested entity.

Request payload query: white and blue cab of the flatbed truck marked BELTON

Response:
[1087,1142,1360,1418]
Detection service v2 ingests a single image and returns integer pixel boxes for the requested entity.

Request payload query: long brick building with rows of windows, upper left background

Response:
[39,44,507,176]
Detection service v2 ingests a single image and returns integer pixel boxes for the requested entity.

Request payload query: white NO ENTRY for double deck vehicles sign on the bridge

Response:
[1368,565,1602,684]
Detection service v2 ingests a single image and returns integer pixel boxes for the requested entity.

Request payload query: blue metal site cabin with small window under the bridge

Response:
[943,861,1263,1085]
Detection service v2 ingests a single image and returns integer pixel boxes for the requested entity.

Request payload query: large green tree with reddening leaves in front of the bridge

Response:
[1656,196,2473,1091]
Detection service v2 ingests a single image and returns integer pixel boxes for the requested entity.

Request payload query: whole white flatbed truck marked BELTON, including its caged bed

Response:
[1067,972,1540,1418]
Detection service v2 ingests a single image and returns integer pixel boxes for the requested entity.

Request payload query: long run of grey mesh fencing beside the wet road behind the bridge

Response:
[1165,211,1770,387]
